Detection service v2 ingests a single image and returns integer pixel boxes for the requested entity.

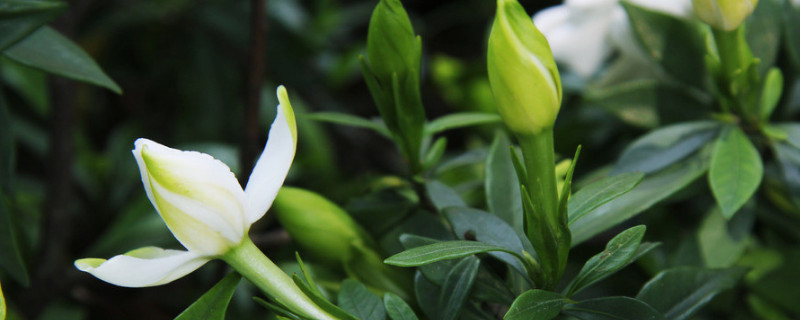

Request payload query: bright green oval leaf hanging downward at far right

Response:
[708,127,764,219]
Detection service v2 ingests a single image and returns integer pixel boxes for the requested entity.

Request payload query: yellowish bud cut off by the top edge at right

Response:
[692,0,758,31]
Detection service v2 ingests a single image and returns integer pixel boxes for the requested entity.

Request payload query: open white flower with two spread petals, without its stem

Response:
[75,86,297,287]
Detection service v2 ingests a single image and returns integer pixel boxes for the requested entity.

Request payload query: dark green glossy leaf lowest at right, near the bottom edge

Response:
[636,267,747,320]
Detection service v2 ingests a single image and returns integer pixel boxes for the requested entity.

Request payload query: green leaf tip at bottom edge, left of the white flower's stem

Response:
[175,272,242,320]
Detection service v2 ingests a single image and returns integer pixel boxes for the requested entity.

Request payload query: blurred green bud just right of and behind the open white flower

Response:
[272,187,375,267]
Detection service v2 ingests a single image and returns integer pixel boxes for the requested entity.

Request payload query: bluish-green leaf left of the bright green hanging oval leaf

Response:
[612,121,719,174]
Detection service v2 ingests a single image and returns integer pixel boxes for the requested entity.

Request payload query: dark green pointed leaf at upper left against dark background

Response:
[3,27,122,94]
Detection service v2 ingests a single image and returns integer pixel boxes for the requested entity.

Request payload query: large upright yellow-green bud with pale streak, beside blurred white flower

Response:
[487,0,561,135]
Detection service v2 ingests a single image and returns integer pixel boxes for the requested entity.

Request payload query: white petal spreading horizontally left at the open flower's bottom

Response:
[75,247,209,287]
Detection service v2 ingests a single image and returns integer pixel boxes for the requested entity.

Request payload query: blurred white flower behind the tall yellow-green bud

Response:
[533,0,692,78]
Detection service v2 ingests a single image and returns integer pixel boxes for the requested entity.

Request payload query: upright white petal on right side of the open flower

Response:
[245,86,297,223]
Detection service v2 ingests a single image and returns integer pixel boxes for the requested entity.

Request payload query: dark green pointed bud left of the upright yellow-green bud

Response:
[367,0,420,80]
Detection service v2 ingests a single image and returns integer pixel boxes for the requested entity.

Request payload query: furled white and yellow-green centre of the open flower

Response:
[133,139,249,255]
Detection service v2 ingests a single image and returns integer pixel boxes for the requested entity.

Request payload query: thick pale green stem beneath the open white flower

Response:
[220,237,336,320]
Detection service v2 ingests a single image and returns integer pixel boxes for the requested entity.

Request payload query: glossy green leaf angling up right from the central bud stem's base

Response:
[566,225,647,297]
